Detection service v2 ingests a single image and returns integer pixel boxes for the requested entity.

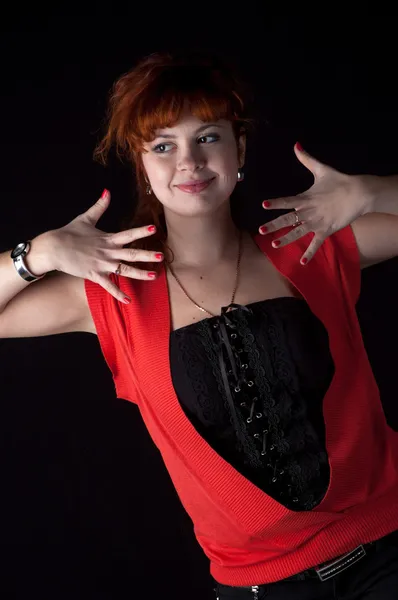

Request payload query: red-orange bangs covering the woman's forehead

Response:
[131,66,243,144]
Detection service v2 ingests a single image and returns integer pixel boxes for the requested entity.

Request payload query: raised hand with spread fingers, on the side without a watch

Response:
[259,144,372,264]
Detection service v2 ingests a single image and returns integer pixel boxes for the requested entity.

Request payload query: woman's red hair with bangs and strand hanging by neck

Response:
[94,53,251,262]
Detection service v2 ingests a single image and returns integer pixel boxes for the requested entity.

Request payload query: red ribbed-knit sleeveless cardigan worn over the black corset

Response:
[86,227,398,586]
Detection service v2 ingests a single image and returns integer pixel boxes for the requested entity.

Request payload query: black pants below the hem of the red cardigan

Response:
[214,531,398,600]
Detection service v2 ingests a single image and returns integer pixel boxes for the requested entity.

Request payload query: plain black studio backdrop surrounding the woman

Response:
[0,2,398,600]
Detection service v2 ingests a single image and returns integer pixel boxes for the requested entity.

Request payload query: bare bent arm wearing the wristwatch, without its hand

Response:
[0,233,96,338]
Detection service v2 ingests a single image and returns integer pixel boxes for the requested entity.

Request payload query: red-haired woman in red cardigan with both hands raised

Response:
[0,55,398,599]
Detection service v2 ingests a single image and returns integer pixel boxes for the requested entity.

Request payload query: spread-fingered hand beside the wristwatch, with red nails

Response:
[32,190,163,303]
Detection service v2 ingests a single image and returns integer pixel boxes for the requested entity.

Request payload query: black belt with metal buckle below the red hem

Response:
[215,530,398,598]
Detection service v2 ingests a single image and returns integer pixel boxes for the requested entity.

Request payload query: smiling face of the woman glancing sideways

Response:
[142,113,245,216]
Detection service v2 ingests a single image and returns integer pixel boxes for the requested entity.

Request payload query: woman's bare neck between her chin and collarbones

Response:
[165,206,239,269]
